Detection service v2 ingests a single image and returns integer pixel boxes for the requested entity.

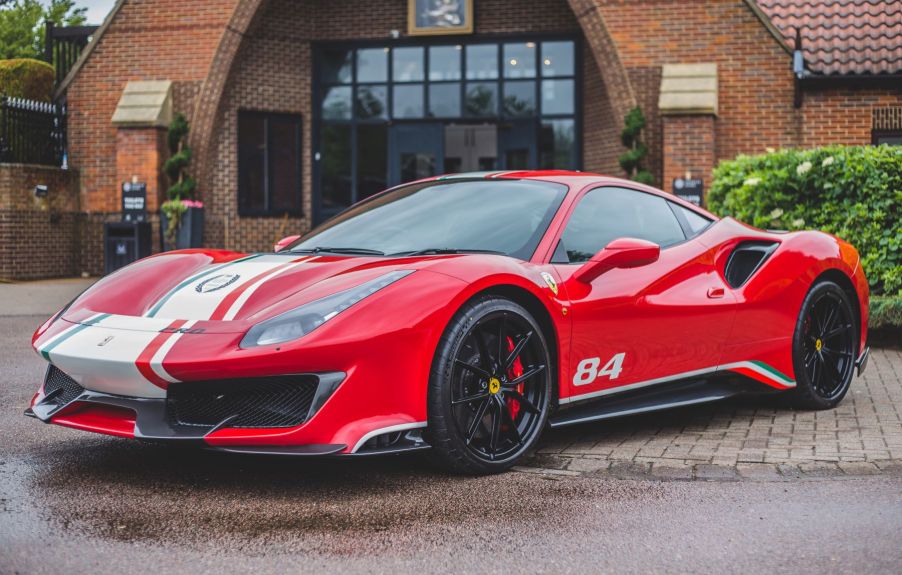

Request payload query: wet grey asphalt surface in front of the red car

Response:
[0,286,902,574]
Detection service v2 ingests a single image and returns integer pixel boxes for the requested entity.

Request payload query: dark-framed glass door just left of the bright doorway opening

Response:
[388,123,444,186]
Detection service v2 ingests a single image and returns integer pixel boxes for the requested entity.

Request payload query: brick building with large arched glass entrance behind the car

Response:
[1,0,902,275]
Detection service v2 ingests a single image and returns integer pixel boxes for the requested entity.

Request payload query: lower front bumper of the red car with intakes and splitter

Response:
[25,365,429,456]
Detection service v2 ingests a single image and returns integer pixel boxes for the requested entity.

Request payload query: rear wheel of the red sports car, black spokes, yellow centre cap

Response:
[791,281,859,409]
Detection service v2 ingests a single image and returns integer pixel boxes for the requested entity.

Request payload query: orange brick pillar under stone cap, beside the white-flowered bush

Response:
[661,115,715,200]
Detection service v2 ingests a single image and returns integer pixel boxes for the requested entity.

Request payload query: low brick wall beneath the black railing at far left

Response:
[0,164,81,280]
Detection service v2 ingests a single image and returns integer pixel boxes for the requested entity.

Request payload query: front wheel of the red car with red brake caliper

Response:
[427,296,552,475]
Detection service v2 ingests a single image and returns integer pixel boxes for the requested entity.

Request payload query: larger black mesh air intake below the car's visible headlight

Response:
[166,375,319,427]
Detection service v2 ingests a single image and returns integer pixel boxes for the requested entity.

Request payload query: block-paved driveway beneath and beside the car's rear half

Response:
[518,349,902,480]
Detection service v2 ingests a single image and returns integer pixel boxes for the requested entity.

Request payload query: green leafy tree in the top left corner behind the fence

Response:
[0,0,87,60]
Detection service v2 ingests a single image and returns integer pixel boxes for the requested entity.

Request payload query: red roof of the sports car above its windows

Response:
[426,170,718,220]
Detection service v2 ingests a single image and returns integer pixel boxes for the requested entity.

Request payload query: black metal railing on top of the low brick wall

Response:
[0,96,66,166]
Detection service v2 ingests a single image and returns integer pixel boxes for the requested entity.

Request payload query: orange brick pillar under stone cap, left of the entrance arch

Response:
[116,127,169,214]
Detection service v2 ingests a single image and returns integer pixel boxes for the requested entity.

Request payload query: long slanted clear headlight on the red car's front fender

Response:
[241,270,414,348]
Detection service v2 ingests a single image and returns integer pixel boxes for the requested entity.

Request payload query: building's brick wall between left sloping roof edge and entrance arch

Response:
[66,0,238,212]
